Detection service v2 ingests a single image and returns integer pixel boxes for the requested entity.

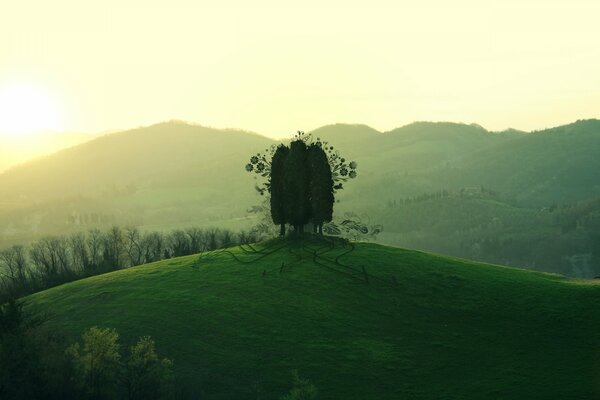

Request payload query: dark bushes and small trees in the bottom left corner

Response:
[0,300,175,400]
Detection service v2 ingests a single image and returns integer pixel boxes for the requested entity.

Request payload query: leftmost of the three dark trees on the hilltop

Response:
[269,144,290,236]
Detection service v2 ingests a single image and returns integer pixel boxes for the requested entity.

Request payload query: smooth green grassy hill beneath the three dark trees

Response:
[25,242,600,399]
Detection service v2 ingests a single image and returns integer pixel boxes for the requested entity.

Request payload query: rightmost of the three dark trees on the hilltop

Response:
[307,143,334,234]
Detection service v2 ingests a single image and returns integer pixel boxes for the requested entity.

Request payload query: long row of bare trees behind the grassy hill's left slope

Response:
[0,226,257,303]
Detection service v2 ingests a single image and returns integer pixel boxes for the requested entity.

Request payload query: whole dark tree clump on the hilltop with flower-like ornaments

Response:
[246,131,357,236]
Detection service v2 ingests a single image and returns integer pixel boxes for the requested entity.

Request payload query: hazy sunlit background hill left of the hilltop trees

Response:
[0,122,273,242]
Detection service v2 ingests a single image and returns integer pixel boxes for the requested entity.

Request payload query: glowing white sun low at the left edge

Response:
[0,84,64,137]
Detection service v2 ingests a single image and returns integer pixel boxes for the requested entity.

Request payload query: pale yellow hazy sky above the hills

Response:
[0,0,600,136]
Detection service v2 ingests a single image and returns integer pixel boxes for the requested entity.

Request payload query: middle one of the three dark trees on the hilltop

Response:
[283,140,310,233]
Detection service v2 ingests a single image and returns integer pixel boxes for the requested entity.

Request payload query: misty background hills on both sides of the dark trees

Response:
[0,119,600,275]
